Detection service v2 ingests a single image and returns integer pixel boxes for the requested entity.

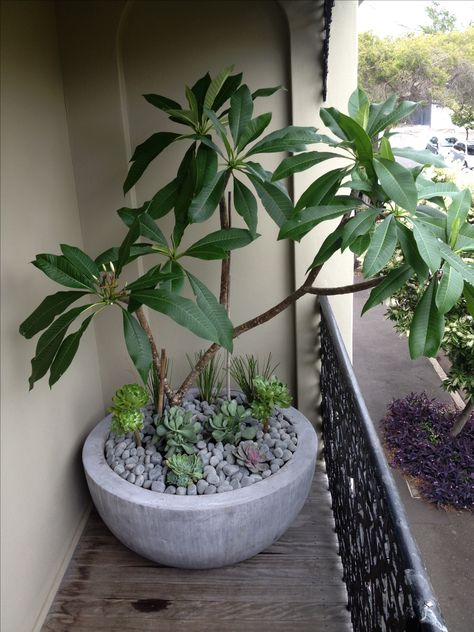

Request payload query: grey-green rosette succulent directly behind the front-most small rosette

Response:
[155,406,202,458]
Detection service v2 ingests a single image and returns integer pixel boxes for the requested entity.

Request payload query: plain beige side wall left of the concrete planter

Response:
[1,1,104,632]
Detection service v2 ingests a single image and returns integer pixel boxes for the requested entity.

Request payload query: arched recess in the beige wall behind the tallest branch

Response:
[119,0,296,396]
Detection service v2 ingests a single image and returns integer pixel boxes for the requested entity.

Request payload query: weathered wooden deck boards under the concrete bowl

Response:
[42,469,352,632]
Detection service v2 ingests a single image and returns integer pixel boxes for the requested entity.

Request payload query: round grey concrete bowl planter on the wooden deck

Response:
[82,408,317,569]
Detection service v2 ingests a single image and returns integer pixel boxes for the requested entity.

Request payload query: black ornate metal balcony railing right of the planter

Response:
[320,297,447,632]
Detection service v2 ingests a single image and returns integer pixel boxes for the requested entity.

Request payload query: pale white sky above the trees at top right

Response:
[358,0,474,37]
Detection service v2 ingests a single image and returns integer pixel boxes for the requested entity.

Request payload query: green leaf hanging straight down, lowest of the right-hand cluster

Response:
[408,276,444,360]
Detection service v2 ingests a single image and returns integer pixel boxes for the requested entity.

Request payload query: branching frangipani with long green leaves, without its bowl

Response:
[20,68,474,428]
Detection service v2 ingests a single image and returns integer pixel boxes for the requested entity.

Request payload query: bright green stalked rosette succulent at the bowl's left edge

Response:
[108,384,148,446]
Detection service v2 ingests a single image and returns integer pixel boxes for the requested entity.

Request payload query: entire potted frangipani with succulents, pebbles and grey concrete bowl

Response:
[20,68,474,568]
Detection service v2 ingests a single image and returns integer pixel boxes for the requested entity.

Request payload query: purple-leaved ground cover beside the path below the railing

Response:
[382,393,474,512]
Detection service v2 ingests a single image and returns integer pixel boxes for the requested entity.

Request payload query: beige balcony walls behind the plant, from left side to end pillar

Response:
[2,0,357,632]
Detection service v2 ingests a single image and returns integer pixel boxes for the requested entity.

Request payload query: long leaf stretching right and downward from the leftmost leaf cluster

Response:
[131,289,219,344]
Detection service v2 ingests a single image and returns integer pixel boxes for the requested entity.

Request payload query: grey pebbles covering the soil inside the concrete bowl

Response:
[105,396,298,496]
